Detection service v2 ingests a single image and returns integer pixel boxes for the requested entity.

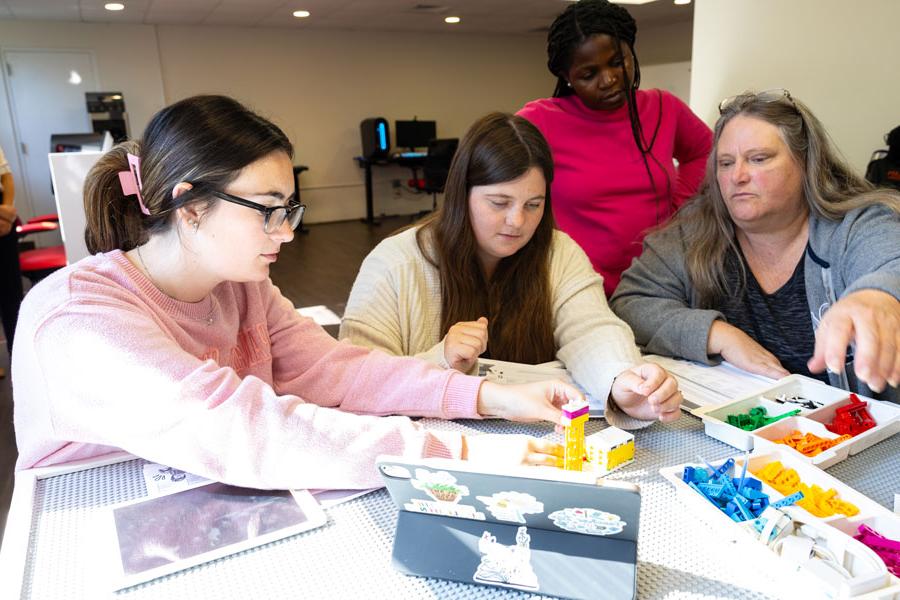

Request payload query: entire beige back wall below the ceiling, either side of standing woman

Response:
[0,20,691,223]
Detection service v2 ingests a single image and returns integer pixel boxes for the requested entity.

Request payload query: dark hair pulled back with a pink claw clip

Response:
[84,96,294,253]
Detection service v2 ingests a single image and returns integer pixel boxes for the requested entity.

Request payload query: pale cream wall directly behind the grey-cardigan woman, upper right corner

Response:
[691,0,900,173]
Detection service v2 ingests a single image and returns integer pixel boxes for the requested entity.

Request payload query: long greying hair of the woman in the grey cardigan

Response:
[664,90,900,308]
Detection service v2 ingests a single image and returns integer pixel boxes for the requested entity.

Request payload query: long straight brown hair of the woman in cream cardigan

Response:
[416,113,556,364]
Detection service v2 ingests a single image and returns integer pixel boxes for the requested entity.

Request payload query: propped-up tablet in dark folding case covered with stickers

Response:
[377,456,641,598]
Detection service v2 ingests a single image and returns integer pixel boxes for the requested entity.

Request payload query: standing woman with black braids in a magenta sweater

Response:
[518,0,712,297]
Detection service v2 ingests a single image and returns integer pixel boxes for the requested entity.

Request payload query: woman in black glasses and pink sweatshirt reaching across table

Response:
[13,96,581,488]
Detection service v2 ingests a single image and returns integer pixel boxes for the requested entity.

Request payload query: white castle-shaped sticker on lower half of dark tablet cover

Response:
[472,527,539,591]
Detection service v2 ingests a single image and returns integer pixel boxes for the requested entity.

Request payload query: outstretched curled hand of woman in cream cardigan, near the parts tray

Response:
[610,363,683,423]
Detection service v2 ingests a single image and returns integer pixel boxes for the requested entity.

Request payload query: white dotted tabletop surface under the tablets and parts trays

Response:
[0,416,900,600]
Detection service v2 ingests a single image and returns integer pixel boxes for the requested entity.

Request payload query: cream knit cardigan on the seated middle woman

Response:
[340,228,653,429]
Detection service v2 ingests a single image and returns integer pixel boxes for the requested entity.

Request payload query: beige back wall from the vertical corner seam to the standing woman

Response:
[159,26,553,222]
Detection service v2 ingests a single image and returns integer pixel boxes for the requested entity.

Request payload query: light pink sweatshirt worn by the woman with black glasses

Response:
[12,251,481,489]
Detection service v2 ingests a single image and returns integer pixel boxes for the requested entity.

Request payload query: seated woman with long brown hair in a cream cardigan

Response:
[340,113,681,428]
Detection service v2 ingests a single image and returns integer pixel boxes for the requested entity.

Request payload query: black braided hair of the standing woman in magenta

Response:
[547,0,671,223]
